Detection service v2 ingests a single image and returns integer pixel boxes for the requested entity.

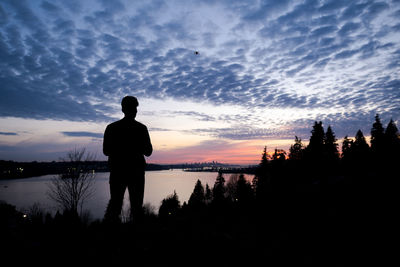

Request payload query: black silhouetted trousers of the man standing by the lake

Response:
[104,170,145,222]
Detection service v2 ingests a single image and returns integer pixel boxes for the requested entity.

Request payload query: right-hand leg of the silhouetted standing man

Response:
[128,171,145,221]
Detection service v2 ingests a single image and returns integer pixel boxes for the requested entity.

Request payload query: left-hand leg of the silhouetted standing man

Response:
[104,173,126,222]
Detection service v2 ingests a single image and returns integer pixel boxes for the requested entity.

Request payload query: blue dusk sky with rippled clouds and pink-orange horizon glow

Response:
[0,0,400,164]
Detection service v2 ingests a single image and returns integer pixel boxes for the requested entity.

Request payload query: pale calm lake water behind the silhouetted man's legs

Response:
[0,172,253,219]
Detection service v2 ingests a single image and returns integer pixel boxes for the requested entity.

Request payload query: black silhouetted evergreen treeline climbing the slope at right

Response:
[159,114,400,217]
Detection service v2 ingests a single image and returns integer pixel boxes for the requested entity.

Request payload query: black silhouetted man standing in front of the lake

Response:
[103,96,153,222]
